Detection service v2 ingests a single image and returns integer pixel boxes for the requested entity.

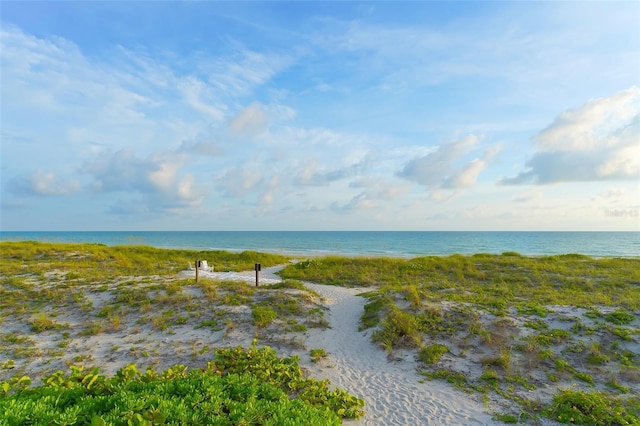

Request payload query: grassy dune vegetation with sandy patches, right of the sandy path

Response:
[281,252,640,424]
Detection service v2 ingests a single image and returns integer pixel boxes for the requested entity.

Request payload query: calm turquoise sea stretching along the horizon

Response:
[0,231,640,257]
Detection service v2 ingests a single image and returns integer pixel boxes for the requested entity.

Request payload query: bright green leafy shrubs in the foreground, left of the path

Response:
[0,345,364,426]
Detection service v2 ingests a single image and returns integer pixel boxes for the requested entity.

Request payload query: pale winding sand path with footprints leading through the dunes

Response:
[305,283,495,425]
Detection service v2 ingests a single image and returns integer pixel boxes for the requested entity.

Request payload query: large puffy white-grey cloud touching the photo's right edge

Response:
[501,86,640,185]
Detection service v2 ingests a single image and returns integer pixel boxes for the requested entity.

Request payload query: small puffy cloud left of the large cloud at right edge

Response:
[397,135,496,189]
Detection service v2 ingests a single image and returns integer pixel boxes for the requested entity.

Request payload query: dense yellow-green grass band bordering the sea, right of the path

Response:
[281,254,640,308]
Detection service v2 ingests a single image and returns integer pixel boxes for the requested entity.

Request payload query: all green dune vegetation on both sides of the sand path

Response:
[0,242,640,425]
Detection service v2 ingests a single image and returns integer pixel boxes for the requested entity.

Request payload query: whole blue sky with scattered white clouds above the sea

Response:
[0,1,640,231]
